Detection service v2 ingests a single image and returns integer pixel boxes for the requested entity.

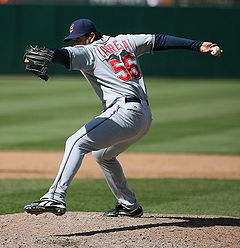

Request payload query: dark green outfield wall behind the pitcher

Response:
[0,4,240,77]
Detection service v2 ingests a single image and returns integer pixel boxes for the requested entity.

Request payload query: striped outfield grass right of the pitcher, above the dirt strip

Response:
[139,80,240,154]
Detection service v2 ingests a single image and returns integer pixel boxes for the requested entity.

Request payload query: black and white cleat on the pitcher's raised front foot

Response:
[24,198,66,216]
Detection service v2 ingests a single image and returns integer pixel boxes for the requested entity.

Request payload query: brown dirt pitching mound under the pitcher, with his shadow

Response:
[0,212,240,248]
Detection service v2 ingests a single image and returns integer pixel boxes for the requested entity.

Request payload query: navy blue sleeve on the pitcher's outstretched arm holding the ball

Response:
[153,34,203,51]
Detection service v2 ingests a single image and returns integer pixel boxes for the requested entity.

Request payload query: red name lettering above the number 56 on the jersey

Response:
[98,40,130,58]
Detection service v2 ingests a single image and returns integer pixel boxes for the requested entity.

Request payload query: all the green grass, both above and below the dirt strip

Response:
[0,76,240,217]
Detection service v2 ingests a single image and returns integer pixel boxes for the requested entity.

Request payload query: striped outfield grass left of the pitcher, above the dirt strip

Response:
[0,77,99,149]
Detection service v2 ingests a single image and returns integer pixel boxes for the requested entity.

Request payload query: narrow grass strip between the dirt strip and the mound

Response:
[0,179,240,217]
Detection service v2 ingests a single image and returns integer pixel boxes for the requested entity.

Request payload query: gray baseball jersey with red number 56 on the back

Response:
[66,34,154,107]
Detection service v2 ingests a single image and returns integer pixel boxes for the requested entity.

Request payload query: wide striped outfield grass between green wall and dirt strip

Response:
[0,76,240,154]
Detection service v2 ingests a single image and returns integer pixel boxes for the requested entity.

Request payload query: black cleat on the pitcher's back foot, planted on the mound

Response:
[103,203,143,217]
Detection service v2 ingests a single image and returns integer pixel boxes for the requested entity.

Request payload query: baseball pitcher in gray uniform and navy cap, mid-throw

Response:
[24,19,222,217]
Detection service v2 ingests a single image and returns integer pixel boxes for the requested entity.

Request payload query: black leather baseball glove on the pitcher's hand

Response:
[23,46,54,81]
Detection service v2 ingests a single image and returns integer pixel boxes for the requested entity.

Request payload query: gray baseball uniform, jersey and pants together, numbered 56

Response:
[42,35,154,209]
